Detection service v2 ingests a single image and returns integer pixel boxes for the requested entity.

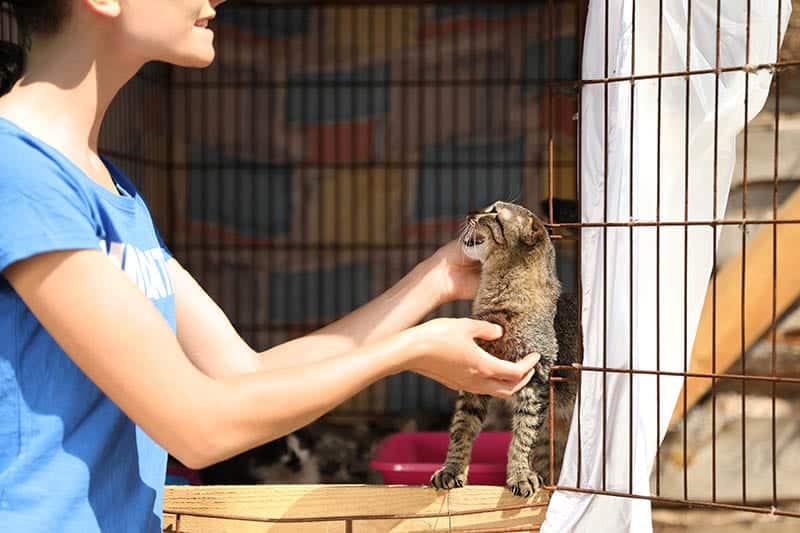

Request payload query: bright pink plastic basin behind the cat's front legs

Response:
[370,431,511,485]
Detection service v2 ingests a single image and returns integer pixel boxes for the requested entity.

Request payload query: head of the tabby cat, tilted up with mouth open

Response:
[462,198,554,265]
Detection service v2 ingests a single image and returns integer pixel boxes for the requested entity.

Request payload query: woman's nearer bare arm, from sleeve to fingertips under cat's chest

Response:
[3,250,536,468]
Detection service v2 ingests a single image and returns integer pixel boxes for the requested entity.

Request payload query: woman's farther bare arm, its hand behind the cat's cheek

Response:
[168,237,480,376]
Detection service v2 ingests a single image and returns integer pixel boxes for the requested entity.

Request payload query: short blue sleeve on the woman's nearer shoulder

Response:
[0,143,99,272]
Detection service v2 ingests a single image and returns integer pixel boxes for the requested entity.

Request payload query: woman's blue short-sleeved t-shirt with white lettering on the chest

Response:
[0,119,175,533]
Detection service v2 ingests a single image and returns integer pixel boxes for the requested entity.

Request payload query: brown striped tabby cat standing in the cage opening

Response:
[431,202,580,498]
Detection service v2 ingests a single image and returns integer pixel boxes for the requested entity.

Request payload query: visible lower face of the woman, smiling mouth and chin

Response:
[118,0,225,67]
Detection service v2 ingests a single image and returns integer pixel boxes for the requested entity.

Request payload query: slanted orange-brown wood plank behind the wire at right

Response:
[670,188,800,425]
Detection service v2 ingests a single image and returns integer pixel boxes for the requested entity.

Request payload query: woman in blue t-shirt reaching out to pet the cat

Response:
[0,0,537,533]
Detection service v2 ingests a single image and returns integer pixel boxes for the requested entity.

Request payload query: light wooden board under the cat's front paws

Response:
[164,485,549,533]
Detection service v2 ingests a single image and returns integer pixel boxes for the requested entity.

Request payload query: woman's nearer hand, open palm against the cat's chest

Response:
[408,318,539,398]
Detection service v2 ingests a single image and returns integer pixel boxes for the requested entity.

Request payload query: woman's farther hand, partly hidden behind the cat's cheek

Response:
[427,240,481,304]
